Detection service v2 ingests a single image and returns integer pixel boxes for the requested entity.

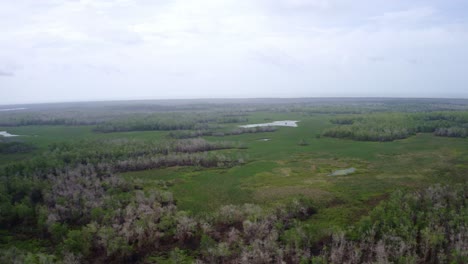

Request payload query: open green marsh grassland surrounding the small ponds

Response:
[122,113,468,229]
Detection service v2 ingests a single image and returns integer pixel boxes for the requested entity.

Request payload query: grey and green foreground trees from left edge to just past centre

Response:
[0,166,315,263]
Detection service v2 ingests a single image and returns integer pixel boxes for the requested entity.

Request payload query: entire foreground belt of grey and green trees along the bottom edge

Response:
[0,166,468,263]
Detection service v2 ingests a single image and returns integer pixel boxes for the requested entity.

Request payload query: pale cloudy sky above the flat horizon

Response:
[0,0,468,104]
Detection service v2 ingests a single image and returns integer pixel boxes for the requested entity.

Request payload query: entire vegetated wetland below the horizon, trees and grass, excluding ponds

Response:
[0,99,468,263]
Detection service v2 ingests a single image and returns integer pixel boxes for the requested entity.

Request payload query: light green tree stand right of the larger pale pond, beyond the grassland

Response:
[323,111,468,141]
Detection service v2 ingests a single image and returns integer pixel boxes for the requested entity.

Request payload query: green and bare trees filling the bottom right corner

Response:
[316,184,468,263]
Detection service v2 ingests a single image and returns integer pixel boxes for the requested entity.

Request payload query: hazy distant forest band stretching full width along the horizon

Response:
[5,98,468,132]
